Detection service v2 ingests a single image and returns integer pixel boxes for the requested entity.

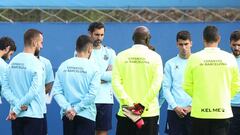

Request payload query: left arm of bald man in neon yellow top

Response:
[112,58,134,106]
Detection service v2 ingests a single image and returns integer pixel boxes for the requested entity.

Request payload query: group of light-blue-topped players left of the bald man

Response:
[0,22,116,135]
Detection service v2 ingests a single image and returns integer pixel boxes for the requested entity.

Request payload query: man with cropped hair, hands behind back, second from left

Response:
[2,29,46,135]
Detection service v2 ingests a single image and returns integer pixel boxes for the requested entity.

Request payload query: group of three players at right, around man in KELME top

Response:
[162,26,240,135]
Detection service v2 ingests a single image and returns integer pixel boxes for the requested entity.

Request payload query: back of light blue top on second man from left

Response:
[7,53,46,118]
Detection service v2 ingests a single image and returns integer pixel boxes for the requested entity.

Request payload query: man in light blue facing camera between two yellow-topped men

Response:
[162,31,192,135]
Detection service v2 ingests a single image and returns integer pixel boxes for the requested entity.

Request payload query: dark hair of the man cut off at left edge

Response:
[0,37,17,51]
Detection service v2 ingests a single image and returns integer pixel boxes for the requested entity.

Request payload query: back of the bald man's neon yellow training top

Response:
[113,45,162,116]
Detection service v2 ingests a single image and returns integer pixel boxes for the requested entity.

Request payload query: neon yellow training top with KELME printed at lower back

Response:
[186,48,239,118]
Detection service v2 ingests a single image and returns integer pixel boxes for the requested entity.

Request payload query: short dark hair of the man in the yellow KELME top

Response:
[203,26,219,43]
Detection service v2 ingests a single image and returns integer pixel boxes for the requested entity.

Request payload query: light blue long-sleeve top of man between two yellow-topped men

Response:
[162,55,192,110]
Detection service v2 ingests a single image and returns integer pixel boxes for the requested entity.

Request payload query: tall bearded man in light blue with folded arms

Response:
[88,22,116,135]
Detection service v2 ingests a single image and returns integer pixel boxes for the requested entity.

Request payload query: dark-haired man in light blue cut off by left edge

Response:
[0,37,16,104]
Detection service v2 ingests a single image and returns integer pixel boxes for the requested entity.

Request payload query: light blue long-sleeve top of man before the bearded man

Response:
[52,57,100,121]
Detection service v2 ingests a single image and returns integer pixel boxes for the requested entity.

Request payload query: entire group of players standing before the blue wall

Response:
[0,22,240,135]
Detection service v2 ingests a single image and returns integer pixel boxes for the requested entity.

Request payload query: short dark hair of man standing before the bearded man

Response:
[76,35,93,52]
